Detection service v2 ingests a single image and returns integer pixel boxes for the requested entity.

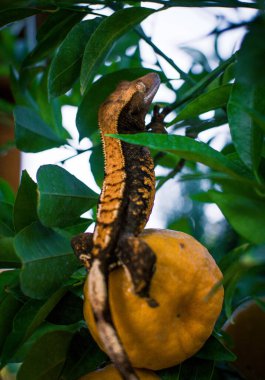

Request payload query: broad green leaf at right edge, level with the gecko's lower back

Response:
[209,191,265,244]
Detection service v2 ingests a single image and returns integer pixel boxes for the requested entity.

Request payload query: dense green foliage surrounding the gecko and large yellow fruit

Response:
[0,0,265,380]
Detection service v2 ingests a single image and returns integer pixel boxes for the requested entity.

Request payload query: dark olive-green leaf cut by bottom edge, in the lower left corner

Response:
[17,331,73,380]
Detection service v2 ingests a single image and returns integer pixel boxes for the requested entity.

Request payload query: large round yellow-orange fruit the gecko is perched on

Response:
[84,229,223,370]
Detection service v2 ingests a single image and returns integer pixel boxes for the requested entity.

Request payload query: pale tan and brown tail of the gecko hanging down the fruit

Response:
[88,259,139,380]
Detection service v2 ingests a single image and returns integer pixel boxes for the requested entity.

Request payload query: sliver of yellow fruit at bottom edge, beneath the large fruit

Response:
[79,365,160,380]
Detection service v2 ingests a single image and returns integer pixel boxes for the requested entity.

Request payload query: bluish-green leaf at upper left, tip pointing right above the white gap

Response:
[14,106,65,152]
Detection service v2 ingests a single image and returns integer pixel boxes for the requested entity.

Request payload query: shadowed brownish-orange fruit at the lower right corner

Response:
[223,298,265,380]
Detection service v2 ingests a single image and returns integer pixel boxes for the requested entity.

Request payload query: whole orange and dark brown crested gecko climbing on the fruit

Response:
[72,73,161,380]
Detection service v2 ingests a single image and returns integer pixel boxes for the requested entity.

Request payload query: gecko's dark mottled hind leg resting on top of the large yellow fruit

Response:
[118,235,158,307]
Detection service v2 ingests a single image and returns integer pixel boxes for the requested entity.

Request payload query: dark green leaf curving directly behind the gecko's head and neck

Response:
[76,68,162,140]
